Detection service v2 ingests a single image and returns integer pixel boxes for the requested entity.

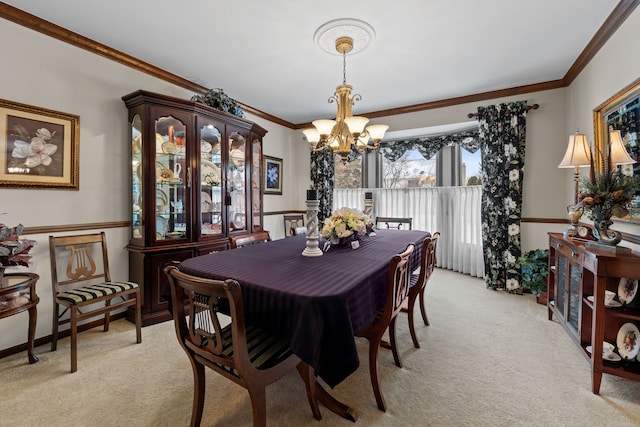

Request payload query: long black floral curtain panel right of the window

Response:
[478,101,527,293]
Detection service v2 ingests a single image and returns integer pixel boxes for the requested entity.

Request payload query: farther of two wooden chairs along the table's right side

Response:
[398,231,440,350]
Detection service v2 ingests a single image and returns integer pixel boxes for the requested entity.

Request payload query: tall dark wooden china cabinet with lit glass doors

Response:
[122,90,266,325]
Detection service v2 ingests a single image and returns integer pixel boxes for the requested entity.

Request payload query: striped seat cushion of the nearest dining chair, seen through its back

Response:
[203,325,293,376]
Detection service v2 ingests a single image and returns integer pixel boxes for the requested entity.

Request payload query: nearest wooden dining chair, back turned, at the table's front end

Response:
[164,264,321,427]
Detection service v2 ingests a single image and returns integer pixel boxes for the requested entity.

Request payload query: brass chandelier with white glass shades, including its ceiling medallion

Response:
[302,19,389,162]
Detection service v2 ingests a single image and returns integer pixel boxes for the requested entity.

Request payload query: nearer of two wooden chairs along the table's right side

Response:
[355,243,415,411]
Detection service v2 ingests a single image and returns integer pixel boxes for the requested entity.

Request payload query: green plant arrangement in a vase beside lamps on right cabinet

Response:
[577,150,640,245]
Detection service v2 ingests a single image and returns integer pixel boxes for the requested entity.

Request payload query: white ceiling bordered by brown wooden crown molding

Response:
[0,0,618,124]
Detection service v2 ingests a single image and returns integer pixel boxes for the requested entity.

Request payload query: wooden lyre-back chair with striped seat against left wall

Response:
[49,232,142,372]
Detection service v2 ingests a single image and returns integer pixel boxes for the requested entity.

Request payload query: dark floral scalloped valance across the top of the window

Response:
[380,127,480,162]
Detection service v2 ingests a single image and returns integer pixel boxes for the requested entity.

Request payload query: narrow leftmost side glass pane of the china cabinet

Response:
[131,114,144,239]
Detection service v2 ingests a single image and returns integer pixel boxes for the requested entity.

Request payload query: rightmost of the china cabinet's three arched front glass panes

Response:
[227,132,249,232]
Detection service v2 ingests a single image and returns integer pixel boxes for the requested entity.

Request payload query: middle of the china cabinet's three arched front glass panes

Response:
[198,123,224,236]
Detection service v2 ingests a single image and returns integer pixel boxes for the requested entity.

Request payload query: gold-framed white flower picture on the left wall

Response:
[0,99,80,191]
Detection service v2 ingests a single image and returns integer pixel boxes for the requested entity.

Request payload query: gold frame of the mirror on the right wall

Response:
[593,78,640,224]
